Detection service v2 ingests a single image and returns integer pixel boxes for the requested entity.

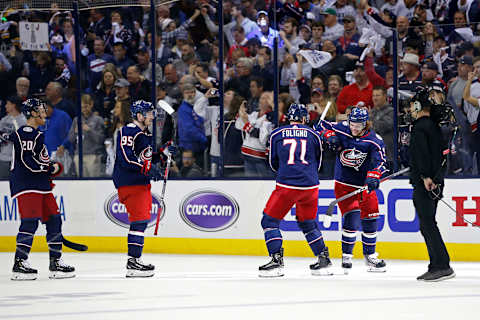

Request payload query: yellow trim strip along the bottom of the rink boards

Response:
[0,236,480,261]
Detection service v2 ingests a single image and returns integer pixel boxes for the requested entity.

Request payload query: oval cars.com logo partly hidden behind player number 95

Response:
[104,193,165,229]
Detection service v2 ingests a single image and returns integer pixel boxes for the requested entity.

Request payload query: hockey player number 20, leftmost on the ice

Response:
[10,99,75,280]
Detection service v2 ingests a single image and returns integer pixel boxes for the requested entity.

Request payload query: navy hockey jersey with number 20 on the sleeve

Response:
[10,125,52,197]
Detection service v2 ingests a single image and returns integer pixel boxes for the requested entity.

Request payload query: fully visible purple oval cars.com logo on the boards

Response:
[180,190,240,232]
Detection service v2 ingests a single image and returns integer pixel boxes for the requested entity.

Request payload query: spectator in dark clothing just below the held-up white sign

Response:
[29,51,55,96]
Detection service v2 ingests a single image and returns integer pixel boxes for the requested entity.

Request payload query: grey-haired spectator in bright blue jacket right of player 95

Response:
[178,83,207,167]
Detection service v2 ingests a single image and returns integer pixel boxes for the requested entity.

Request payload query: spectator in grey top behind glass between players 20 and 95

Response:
[64,94,105,178]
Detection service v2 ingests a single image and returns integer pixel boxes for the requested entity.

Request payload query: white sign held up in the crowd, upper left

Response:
[19,21,50,51]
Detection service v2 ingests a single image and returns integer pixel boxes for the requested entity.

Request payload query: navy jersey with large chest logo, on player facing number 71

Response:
[316,120,387,187]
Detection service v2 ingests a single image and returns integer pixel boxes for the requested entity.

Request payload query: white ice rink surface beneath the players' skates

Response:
[0,253,480,320]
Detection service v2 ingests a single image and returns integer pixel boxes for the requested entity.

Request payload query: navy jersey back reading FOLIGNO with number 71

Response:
[269,124,322,189]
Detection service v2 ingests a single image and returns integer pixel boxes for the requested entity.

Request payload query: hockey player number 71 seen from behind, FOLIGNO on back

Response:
[259,104,332,277]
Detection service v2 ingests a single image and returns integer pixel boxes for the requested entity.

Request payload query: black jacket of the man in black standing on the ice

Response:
[409,117,448,186]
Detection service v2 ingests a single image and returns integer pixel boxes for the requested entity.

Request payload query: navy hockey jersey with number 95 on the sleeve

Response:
[113,123,152,189]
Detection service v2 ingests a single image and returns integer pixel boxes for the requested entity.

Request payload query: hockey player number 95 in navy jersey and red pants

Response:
[113,100,175,277]
